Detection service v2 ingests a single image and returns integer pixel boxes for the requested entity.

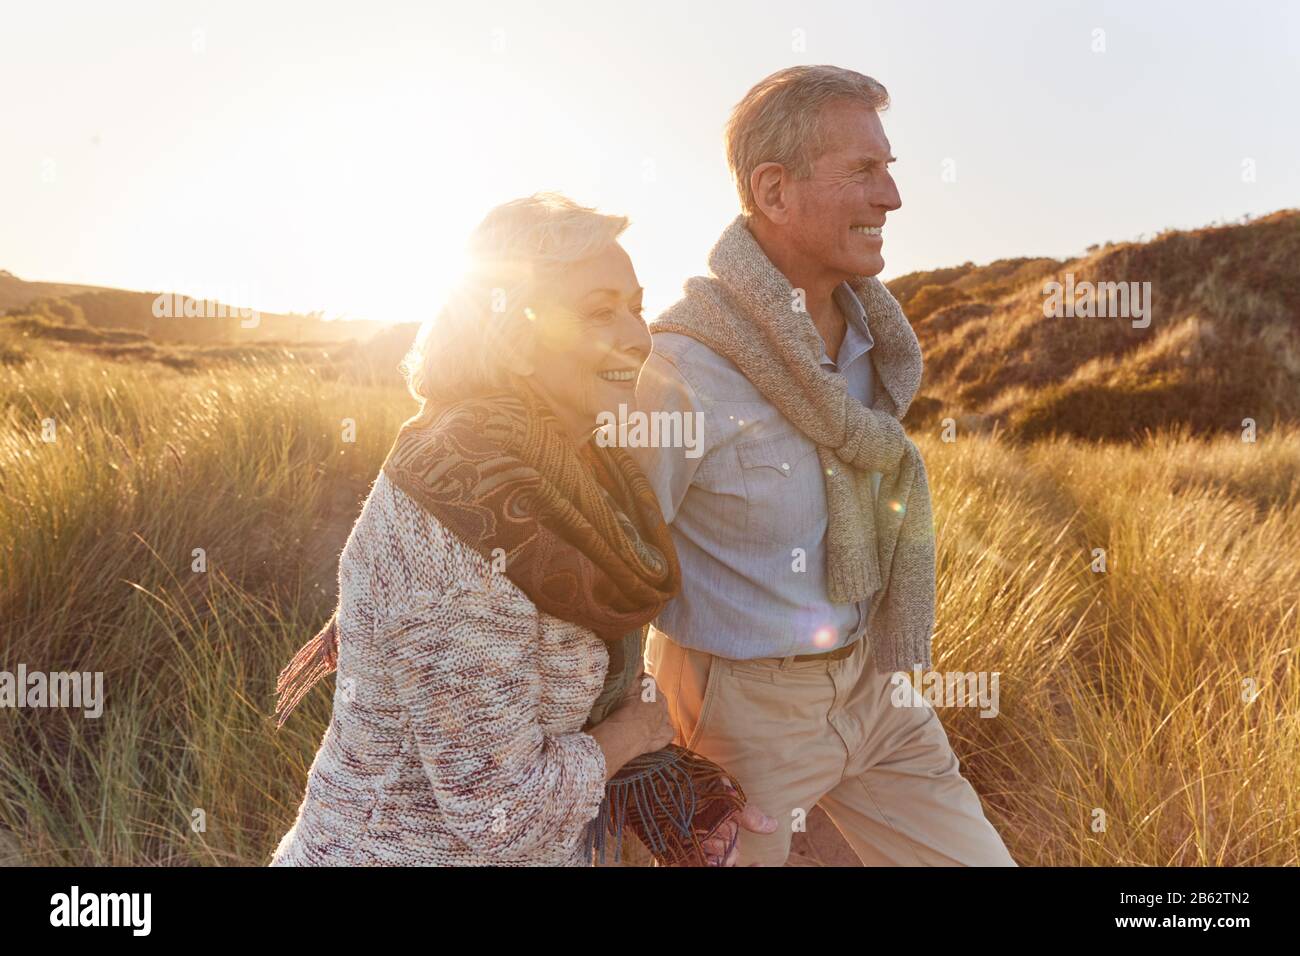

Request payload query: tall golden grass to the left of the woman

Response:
[0,343,411,865]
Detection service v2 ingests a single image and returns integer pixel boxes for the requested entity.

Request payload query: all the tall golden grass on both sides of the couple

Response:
[0,343,1300,865]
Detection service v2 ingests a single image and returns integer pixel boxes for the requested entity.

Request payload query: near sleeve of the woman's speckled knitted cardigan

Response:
[380,541,606,861]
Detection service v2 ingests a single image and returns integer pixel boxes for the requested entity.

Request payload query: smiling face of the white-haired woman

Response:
[529,243,650,441]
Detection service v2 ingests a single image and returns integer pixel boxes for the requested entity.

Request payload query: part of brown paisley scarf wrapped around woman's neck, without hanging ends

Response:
[384,393,681,641]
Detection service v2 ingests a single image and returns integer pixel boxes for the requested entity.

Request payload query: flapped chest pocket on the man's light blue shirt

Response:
[736,432,824,549]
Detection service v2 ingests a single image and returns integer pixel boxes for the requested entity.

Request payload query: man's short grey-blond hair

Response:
[727,66,889,216]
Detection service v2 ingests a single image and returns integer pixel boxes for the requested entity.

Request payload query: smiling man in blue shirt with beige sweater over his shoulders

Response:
[633,66,1015,866]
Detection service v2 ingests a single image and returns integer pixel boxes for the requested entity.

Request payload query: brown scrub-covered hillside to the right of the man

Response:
[888,209,1300,440]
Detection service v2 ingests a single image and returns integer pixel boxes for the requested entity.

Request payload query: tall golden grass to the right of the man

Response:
[923,431,1300,866]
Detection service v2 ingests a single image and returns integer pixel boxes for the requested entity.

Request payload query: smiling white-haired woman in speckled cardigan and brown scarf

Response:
[272,195,775,865]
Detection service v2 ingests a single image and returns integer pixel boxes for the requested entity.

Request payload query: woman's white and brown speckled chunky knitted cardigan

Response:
[272,473,608,866]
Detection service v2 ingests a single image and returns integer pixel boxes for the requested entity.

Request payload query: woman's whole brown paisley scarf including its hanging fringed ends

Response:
[276,393,744,864]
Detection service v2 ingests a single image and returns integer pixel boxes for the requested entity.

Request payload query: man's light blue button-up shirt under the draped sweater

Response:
[629,284,880,659]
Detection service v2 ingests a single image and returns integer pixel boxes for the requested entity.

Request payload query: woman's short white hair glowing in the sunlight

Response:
[402,193,628,407]
